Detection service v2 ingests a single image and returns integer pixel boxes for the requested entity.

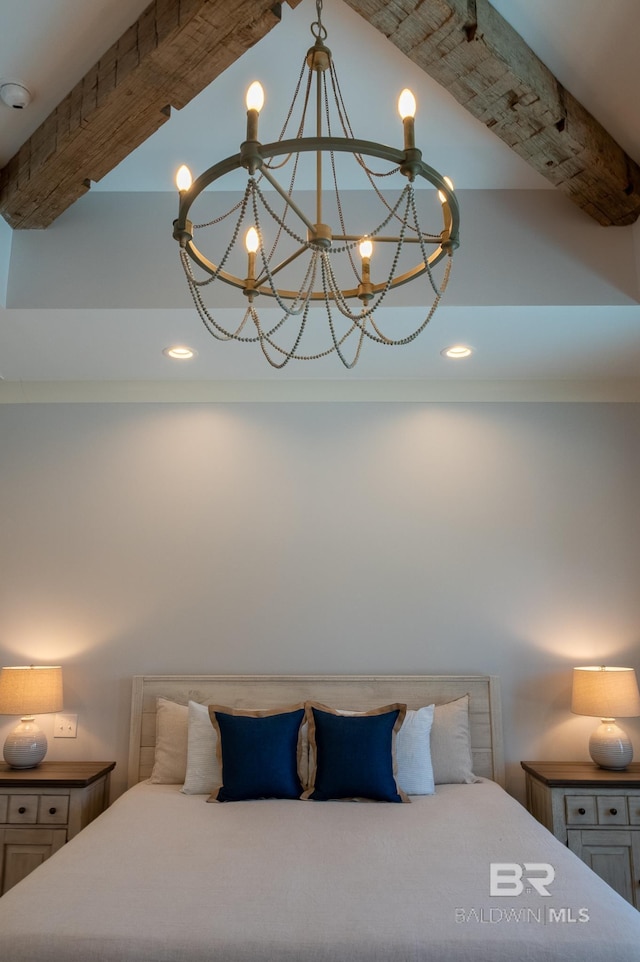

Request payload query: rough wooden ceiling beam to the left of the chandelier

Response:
[0,0,300,228]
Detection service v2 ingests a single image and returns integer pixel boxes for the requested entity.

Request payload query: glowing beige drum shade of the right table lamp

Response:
[571,665,640,718]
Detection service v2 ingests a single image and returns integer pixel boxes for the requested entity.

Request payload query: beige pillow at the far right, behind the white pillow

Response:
[431,695,480,785]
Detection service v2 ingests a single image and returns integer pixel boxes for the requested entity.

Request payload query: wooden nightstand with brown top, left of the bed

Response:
[0,762,116,895]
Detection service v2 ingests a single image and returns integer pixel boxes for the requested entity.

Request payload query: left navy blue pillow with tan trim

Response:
[209,705,304,802]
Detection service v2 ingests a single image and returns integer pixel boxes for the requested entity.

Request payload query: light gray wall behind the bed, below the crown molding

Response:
[0,403,640,795]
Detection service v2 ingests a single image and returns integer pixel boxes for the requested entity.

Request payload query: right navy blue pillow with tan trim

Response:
[305,703,408,802]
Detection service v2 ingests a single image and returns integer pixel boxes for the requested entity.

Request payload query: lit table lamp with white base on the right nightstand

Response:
[571,665,640,771]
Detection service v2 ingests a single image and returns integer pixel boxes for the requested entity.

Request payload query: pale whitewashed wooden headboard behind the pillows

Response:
[129,675,504,786]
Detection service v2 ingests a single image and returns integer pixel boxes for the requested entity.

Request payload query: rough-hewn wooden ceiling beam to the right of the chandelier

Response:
[345,0,640,226]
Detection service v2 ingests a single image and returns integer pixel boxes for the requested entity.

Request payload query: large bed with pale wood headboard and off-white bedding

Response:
[0,676,640,962]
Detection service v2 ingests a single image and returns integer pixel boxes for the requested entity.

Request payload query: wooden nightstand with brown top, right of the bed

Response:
[521,762,640,909]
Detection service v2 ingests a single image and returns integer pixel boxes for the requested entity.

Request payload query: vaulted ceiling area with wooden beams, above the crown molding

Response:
[0,0,640,402]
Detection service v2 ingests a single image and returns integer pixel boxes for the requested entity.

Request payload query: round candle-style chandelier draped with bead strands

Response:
[173,0,459,368]
